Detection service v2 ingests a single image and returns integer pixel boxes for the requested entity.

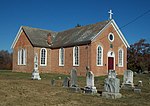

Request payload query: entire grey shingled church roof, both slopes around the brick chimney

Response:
[22,21,110,48]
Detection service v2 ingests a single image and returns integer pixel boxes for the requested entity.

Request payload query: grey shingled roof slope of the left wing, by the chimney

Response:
[22,26,57,47]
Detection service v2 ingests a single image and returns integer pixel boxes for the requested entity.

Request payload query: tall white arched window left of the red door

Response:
[96,45,103,66]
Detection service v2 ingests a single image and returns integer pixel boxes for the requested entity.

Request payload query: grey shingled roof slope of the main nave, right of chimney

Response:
[52,21,110,48]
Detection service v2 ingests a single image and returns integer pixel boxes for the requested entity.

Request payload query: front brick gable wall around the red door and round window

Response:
[91,25,127,76]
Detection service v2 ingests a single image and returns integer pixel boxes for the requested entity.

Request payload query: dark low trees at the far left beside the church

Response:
[0,50,12,70]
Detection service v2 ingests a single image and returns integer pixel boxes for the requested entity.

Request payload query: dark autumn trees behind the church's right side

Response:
[128,39,150,72]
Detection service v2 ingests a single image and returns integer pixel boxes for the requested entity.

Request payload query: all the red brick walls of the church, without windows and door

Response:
[13,25,127,76]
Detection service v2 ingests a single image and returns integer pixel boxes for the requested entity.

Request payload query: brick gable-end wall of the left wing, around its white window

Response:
[13,32,34,72]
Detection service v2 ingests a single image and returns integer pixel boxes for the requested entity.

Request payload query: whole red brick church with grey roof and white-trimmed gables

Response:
[12,12,130,76]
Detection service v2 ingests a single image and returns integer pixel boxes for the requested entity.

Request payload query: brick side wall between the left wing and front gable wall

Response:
[51,45,90,76]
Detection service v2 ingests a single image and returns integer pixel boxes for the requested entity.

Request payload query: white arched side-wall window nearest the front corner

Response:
[73,46,79,66]
